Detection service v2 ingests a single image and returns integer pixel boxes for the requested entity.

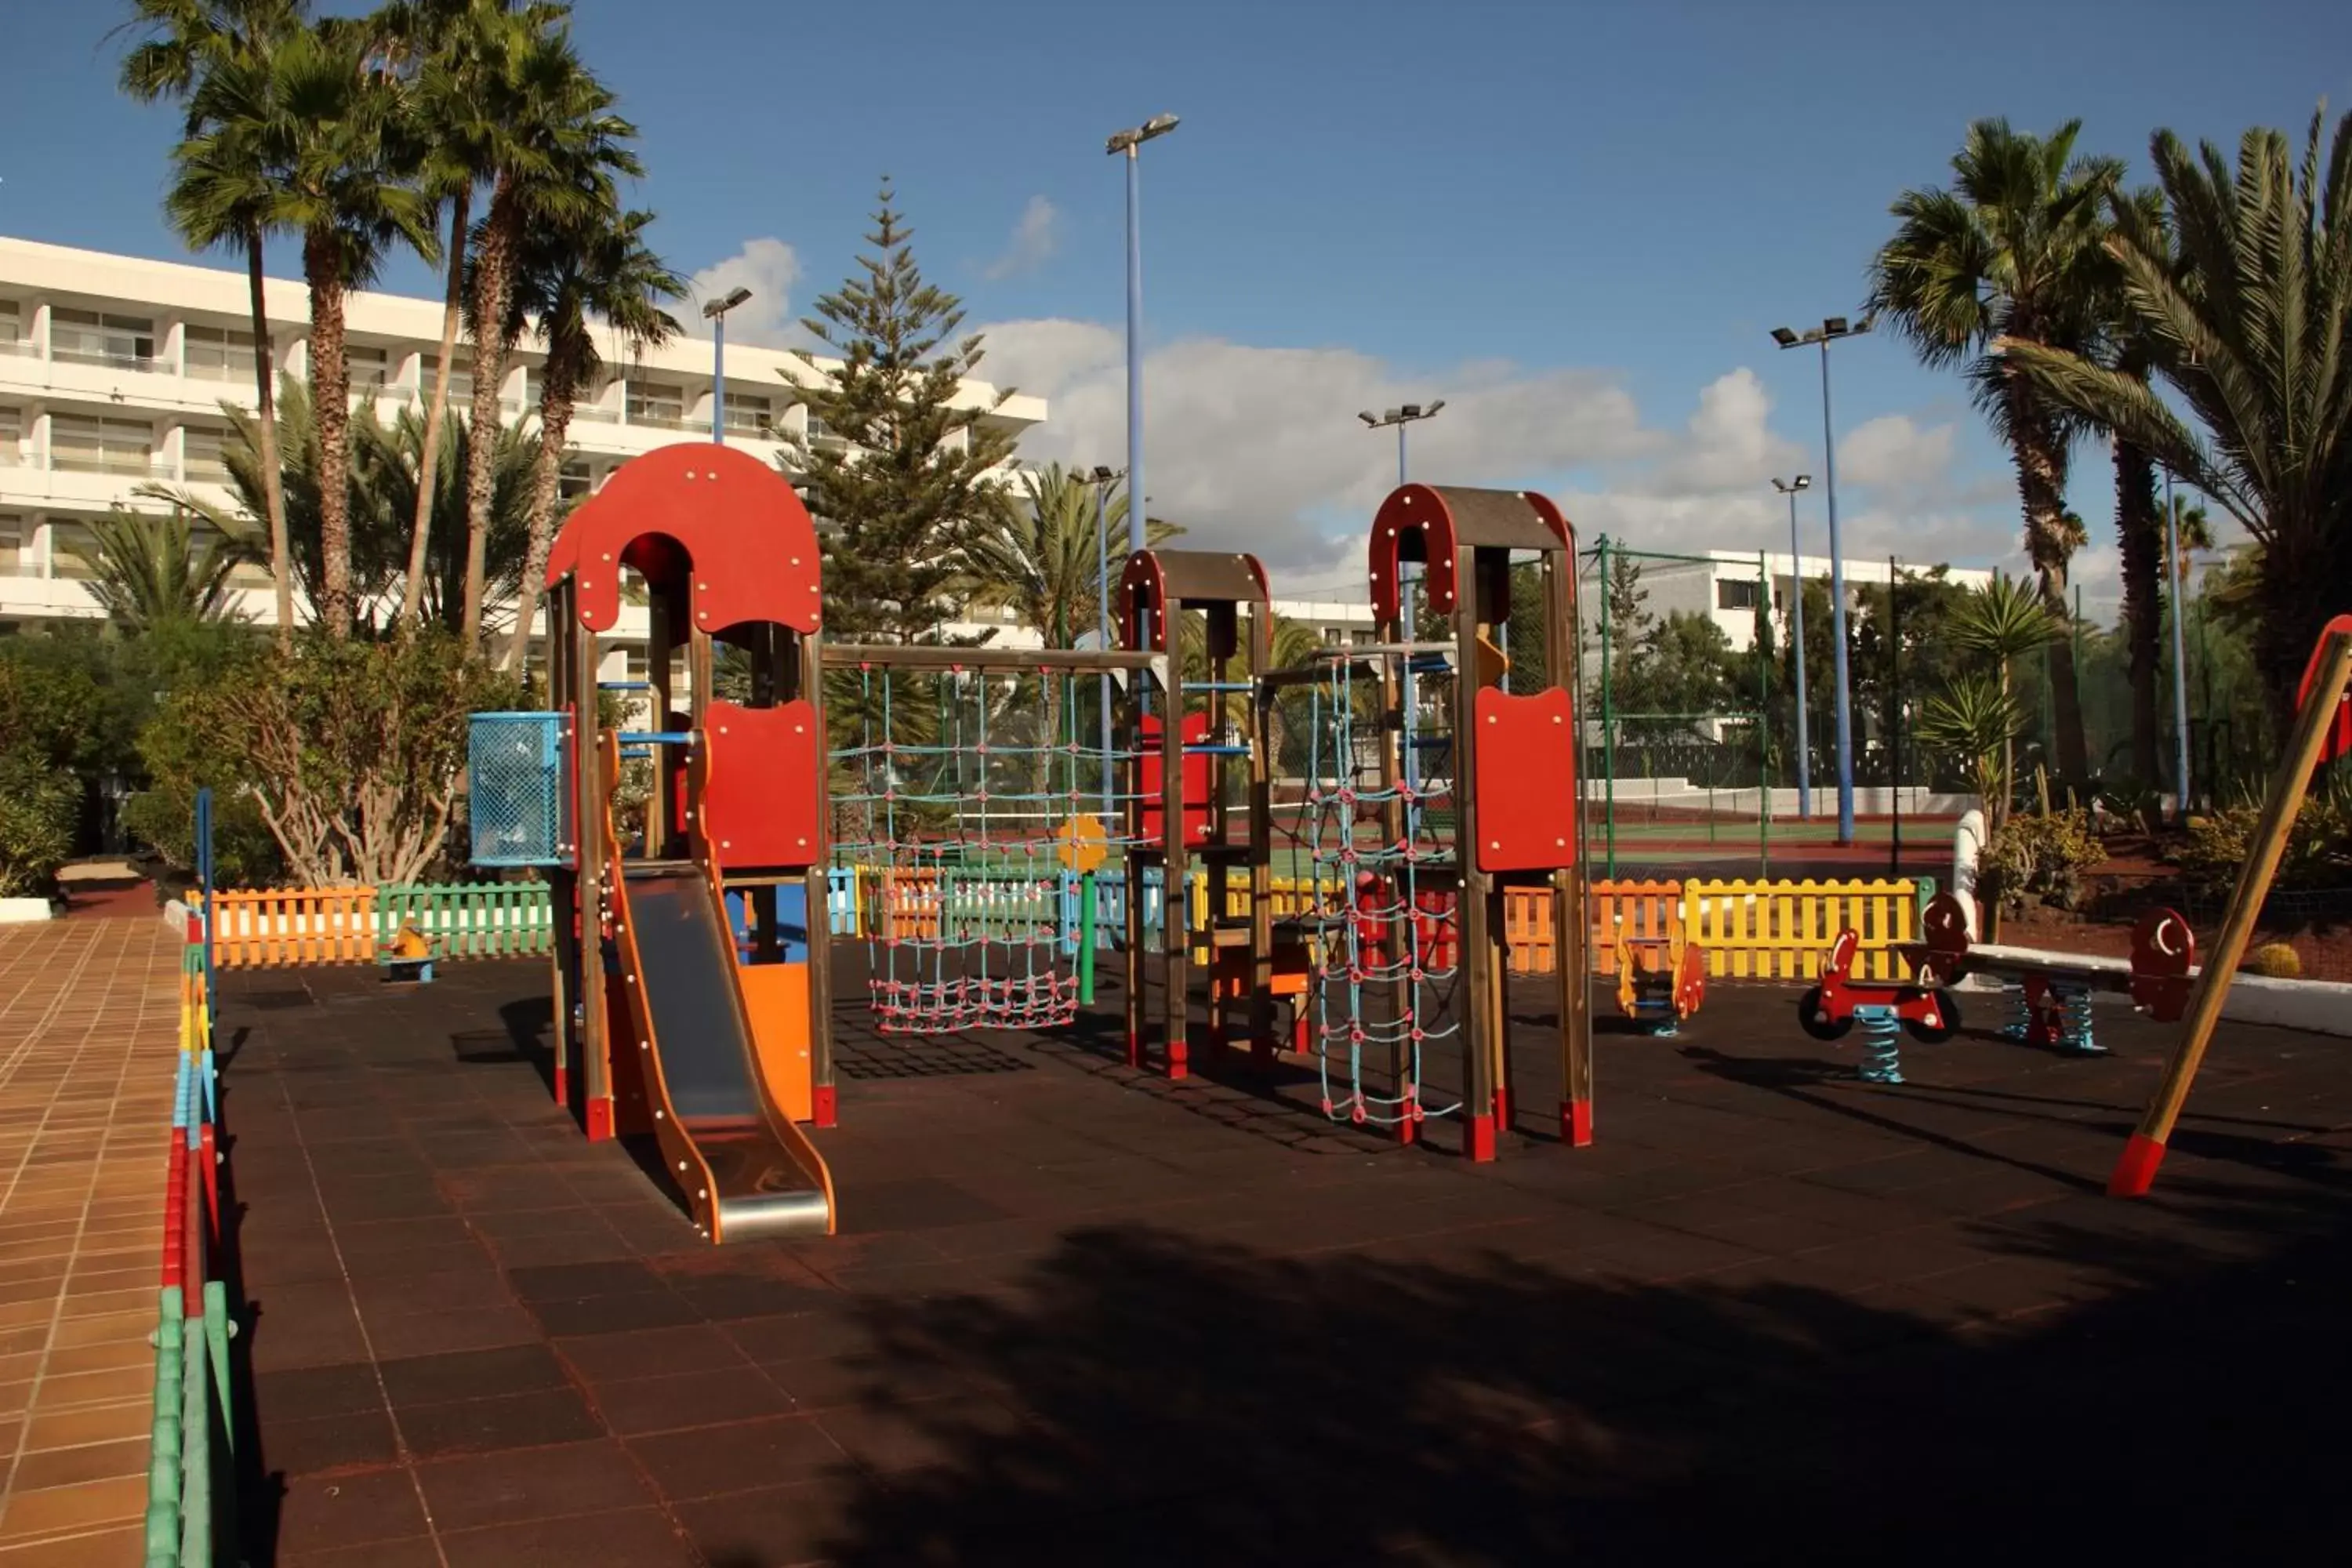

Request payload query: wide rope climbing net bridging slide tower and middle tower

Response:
[828,654,1131,1034]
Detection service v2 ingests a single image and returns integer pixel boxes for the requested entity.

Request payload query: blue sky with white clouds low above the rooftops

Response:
[0,0,2352,614]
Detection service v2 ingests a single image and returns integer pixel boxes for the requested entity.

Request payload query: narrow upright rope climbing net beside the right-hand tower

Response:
[1303,654,1463,1126]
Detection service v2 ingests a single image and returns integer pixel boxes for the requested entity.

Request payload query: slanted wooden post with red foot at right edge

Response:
[2107,626,2352,1196]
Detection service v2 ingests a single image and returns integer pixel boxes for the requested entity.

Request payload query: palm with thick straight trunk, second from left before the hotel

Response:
[183,19,437,637]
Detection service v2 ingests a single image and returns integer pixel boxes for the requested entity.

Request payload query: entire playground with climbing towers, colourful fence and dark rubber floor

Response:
[55,447,2352,1568]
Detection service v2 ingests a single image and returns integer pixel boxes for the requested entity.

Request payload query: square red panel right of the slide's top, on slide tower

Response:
[703,703,826,869]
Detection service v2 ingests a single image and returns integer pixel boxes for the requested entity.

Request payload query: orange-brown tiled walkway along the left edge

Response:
[0,912,179,1568]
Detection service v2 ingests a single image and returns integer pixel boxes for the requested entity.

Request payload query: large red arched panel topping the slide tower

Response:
[548,442,823,633]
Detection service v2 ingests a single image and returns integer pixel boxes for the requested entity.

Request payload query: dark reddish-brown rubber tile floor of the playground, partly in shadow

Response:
[219,940,2352,1568]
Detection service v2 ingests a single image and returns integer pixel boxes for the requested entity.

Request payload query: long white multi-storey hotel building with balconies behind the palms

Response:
[0,238,1371,663]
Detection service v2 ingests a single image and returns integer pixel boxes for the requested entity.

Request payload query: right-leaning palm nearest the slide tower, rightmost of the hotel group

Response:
[506,209,687,673]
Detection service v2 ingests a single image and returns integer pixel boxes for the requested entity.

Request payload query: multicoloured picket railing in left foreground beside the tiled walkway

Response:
[143,928,238,1568]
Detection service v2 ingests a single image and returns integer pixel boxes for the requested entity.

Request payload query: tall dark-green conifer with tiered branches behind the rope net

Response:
[795,179,1014,642]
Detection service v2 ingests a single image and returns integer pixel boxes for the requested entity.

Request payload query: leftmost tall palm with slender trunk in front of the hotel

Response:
[120,0,308,644]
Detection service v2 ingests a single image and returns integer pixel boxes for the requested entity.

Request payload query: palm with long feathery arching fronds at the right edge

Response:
[1997,111,2352,734]
